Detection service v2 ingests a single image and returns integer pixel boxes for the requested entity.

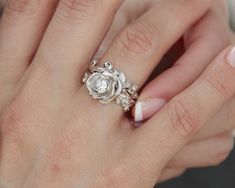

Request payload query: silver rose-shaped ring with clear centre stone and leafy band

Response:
[83,60,138,112]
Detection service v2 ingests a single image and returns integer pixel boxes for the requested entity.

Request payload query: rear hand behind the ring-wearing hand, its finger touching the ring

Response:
[93,0,235,180]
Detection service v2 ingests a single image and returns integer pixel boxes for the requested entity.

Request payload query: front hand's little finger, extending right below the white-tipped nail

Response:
[129,47,235,182]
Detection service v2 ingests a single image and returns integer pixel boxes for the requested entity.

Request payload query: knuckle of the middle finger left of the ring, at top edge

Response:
[57,0,101,22]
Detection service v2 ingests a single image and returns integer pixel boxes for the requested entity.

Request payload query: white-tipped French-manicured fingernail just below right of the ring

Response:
[135,98,167,122]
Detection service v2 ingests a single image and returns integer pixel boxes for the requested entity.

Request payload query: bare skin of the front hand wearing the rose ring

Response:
[0,0,235,188]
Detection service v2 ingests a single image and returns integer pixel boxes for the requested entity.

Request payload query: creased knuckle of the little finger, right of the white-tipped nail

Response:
[168,100,200,137]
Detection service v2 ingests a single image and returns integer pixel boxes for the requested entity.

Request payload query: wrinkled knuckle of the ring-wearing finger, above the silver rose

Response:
[118,23,156,53]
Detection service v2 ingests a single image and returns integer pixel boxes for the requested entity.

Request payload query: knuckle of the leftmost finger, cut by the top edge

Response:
[5,0,40,16]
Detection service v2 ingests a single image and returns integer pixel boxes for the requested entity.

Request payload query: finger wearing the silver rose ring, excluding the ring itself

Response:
[79,0,213,119]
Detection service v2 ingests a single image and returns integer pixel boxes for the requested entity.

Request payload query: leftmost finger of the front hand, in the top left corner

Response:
[0,0,57,85]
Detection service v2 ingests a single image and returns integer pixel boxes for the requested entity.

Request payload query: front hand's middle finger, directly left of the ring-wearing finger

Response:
[28,0,123,96]
